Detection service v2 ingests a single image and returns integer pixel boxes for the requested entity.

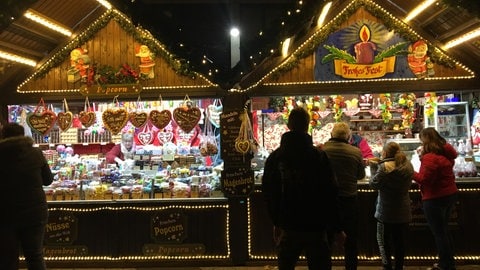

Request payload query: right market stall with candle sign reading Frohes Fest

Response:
[225,0,480,266]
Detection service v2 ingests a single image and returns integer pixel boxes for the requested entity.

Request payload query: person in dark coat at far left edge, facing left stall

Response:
[0,123,53,270]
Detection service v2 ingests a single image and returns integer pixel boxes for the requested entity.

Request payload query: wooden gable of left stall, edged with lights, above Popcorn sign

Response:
[17,9,220,103]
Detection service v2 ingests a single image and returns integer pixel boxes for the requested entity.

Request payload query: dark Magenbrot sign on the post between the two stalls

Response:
[221,167,255,197]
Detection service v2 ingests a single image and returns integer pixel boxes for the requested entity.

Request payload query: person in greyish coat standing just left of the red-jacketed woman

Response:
[369,142,414,270]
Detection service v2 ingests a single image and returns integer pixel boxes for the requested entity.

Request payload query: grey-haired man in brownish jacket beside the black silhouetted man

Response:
[322,122,365,270]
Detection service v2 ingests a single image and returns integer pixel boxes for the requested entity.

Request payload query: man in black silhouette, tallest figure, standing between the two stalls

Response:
[262,107,344,270]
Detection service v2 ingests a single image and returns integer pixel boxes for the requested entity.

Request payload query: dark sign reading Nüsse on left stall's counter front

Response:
[45,212,78,245]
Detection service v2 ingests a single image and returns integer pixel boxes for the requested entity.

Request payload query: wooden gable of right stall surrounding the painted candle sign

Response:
[238,0,480,96]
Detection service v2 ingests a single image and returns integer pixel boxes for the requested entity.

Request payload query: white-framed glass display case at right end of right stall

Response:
[424,102,471,145]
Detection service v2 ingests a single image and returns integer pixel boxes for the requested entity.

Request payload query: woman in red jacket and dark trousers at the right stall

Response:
[413,128,458,270]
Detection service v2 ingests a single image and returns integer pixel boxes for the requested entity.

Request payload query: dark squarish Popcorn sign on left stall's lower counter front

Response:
[151,210,187,243]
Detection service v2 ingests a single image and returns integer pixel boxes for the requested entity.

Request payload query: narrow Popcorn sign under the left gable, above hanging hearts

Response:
[80,84,142,97]
